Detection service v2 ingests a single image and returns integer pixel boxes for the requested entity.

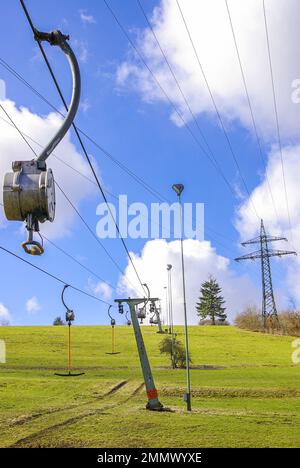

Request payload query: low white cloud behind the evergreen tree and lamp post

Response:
[118,239,260,324]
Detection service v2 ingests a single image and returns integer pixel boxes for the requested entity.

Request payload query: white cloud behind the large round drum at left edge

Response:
[0,96,95,238]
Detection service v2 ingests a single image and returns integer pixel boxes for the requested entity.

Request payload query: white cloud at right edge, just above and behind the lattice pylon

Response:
[236,145,300,304]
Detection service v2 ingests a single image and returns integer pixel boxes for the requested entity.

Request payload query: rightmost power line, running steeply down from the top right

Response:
[263,0,293,242]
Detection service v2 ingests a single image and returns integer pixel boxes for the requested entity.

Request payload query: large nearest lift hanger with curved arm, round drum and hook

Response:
[3,30,81,255]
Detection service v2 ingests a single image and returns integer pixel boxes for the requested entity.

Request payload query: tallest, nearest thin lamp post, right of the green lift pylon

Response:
[172,184,192,411]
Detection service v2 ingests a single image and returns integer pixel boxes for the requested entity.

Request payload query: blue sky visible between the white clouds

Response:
[0,0,292,325]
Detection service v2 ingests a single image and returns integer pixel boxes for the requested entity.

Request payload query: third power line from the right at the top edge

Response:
[176,0,259,218]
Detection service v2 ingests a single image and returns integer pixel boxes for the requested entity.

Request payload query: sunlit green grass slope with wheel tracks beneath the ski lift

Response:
[0,326,300,447]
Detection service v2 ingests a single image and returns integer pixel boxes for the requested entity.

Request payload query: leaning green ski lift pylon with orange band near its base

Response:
[115,288,163,411]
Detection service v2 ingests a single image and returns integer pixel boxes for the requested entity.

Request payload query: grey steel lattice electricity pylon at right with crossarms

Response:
[235,220,297,324]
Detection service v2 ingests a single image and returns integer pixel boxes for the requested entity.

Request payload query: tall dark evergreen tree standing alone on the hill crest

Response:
[196,276,227,325]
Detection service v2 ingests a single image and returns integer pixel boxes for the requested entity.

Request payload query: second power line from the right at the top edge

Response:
[225,0,279,222]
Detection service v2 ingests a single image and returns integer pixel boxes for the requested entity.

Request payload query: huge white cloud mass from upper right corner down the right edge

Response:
[116,0,300,308]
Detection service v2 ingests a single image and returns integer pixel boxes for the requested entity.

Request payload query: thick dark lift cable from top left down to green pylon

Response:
[20,0,145,291]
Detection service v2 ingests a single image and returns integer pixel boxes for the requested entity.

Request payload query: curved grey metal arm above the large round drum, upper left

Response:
[34,30,81,162]
